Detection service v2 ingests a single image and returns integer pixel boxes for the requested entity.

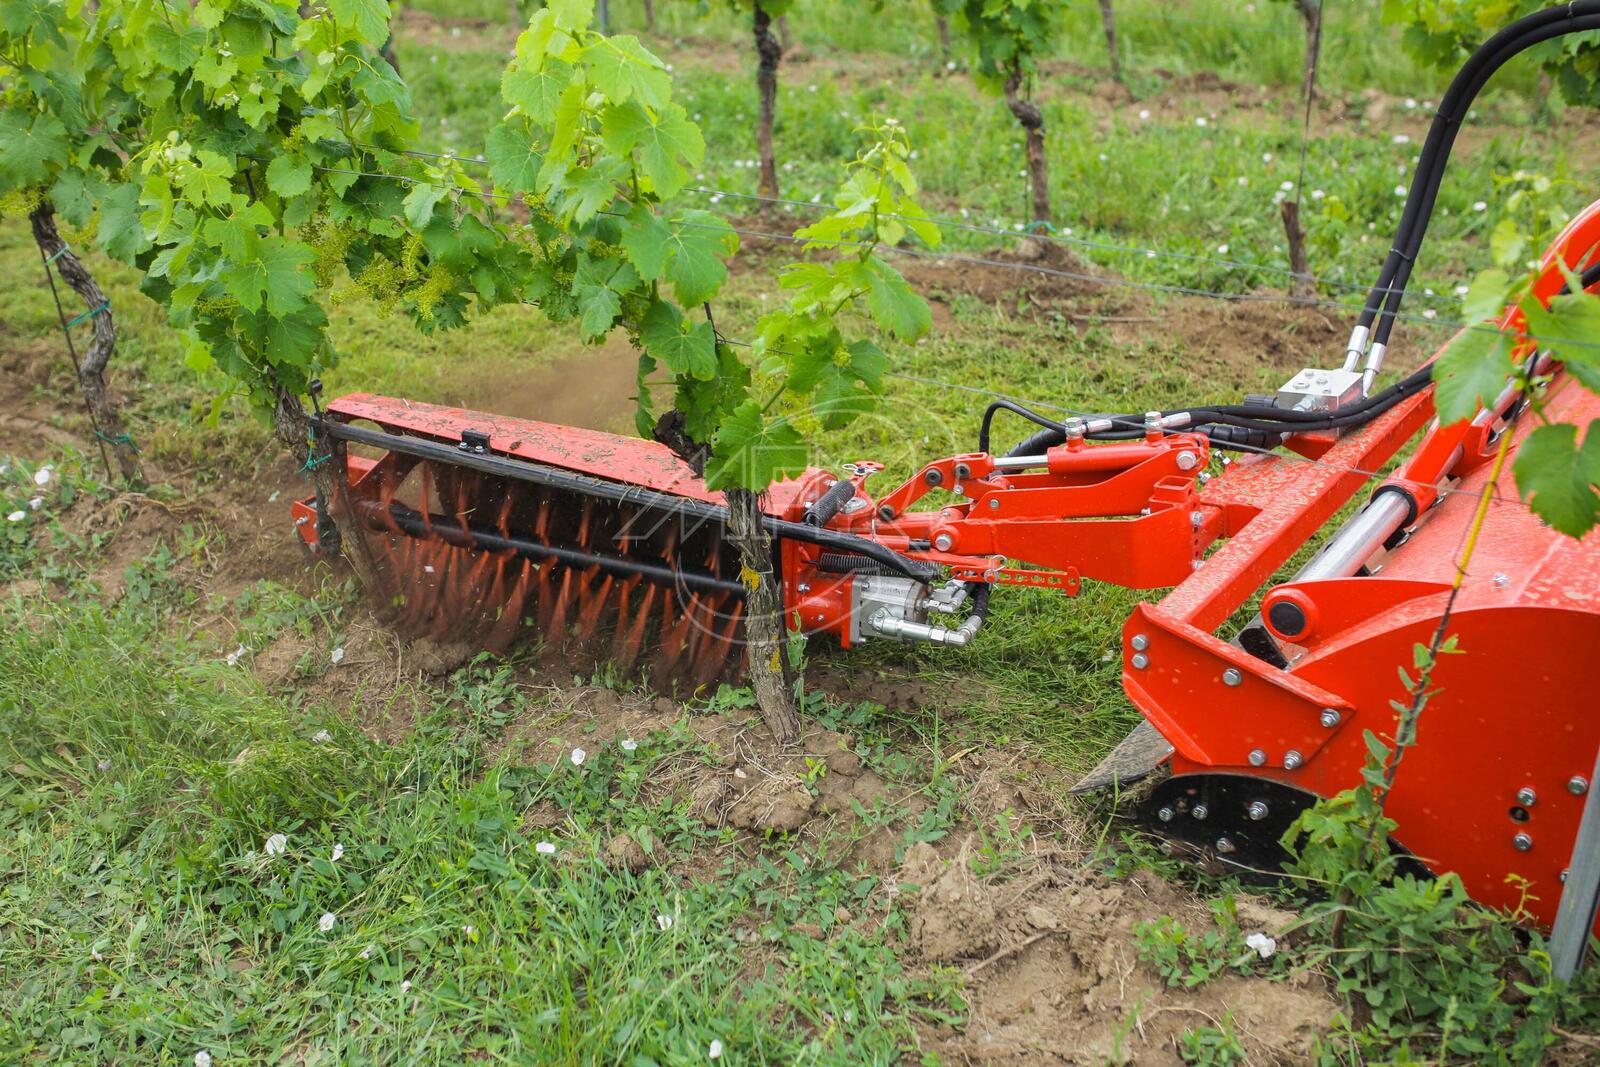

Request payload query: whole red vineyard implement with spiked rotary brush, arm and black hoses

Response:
[296,3,1600,923]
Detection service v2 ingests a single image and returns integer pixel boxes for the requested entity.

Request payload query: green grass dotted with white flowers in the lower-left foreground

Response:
[0,537,960,1065]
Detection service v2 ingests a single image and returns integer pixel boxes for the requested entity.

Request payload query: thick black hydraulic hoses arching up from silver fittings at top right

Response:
[1358,0,1600,351]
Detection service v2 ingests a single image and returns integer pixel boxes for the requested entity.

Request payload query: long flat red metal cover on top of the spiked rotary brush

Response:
[328,394,723,504]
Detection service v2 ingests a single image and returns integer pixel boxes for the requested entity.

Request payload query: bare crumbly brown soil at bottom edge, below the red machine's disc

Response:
[898,841,1338,1064]
